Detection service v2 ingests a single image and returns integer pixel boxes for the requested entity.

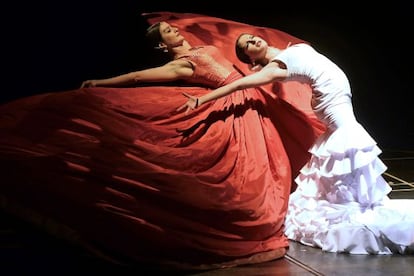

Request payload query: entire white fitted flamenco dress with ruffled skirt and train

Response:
[276,44,414,254]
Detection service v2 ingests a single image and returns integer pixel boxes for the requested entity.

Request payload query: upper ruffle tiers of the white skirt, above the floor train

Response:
[296,123,391,207]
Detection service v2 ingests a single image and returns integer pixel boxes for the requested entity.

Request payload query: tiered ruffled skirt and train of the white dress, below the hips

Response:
[285,122,414,254]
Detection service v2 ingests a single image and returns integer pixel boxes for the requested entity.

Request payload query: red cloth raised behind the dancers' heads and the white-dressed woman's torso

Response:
[143,11,325,178]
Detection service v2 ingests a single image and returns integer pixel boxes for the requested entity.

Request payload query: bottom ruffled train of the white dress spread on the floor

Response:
[285,197,414,255]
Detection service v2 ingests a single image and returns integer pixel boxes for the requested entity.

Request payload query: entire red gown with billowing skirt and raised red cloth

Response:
[0,12,323,268]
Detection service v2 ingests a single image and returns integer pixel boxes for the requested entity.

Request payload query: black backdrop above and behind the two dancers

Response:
[0,0,414,150]
